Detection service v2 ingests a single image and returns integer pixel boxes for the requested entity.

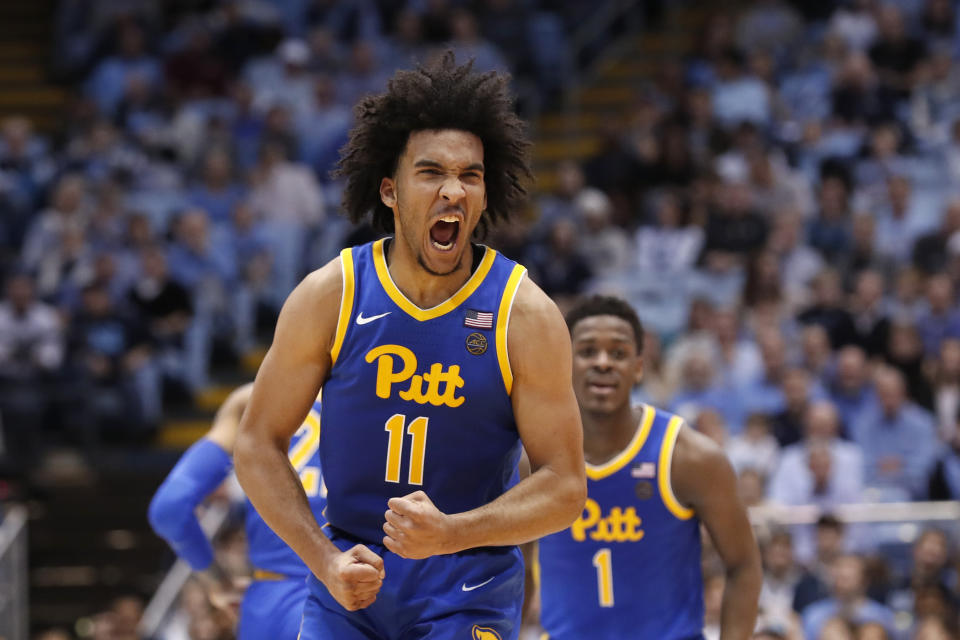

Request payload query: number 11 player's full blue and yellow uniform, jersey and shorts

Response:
[301,240,525,640]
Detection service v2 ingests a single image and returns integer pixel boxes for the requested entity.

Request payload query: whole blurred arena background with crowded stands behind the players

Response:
[0,0,960,640]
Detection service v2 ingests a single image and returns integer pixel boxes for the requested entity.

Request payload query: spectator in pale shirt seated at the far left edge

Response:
[0,272,64,469]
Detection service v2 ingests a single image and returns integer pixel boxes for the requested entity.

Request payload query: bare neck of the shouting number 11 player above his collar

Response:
[387,238,474,309]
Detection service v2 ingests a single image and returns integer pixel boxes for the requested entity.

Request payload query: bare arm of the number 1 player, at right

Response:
[670,427,763,640]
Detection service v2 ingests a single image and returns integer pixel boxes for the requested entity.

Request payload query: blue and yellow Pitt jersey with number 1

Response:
[539,405,703,640]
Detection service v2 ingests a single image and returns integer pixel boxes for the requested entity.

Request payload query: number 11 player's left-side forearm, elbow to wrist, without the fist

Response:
[234,432,337,577]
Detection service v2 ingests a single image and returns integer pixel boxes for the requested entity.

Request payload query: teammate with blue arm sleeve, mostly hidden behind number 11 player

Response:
[149,384,326,640]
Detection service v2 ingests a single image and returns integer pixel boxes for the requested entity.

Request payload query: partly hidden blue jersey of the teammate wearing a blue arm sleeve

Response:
[245,400,327,578]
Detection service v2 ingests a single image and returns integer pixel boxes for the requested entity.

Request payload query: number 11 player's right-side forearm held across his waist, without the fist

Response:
[442,467,586,552]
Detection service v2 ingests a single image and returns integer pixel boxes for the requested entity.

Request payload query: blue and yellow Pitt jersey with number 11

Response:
[320,240,525,543]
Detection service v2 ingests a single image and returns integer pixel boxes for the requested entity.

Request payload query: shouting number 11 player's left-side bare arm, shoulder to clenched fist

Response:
[234,259,383,610]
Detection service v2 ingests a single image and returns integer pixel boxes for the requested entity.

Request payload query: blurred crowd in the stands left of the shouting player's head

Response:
[0,0,585,471]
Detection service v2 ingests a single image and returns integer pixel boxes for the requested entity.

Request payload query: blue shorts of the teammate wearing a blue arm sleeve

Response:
[237,578,307,640]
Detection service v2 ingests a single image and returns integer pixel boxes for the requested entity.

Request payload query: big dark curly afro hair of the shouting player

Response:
[334,51,531,234]
